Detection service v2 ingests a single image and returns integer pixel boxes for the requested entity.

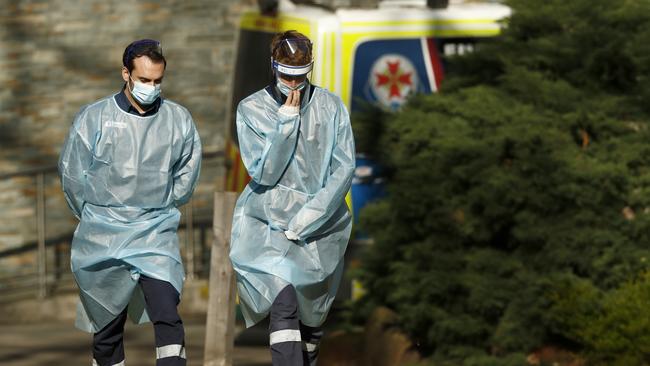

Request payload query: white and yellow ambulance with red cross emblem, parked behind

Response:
[225,0,511,197]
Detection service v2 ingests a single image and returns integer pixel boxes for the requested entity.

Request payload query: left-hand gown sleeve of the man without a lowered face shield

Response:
[58,110,93,219]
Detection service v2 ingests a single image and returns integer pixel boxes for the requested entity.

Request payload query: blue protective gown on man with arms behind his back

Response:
[59,96,201,332]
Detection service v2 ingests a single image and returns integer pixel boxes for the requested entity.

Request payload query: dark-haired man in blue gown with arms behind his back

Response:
[59,39,201,366]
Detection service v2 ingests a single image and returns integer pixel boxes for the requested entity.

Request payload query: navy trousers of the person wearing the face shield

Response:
[269,285,323,366]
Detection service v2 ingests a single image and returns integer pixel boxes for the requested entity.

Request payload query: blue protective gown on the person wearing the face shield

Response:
[230,85,355,327]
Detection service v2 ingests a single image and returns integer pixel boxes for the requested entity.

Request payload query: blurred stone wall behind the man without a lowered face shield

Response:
[0,0,256,277]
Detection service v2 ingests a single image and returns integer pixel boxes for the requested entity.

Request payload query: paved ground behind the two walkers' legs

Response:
[0,317,271,366]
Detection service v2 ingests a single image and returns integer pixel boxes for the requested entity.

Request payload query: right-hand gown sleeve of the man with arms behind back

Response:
[173,119,201,207]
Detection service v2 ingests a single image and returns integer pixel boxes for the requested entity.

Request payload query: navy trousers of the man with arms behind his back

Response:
[93,276,186,366]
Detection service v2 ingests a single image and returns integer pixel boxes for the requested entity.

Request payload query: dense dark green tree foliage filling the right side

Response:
[356,0,650,365]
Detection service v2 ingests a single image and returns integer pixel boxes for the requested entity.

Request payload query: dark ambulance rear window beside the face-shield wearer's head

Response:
[230,29,274,142]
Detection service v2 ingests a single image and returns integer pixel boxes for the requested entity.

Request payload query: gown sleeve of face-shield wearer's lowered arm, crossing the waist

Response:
[288,103,355,240]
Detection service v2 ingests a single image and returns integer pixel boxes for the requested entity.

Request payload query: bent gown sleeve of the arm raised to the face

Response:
[237,104,300,186]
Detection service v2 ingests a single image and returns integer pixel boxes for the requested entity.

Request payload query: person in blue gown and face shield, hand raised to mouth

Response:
[225,31,355,365]
